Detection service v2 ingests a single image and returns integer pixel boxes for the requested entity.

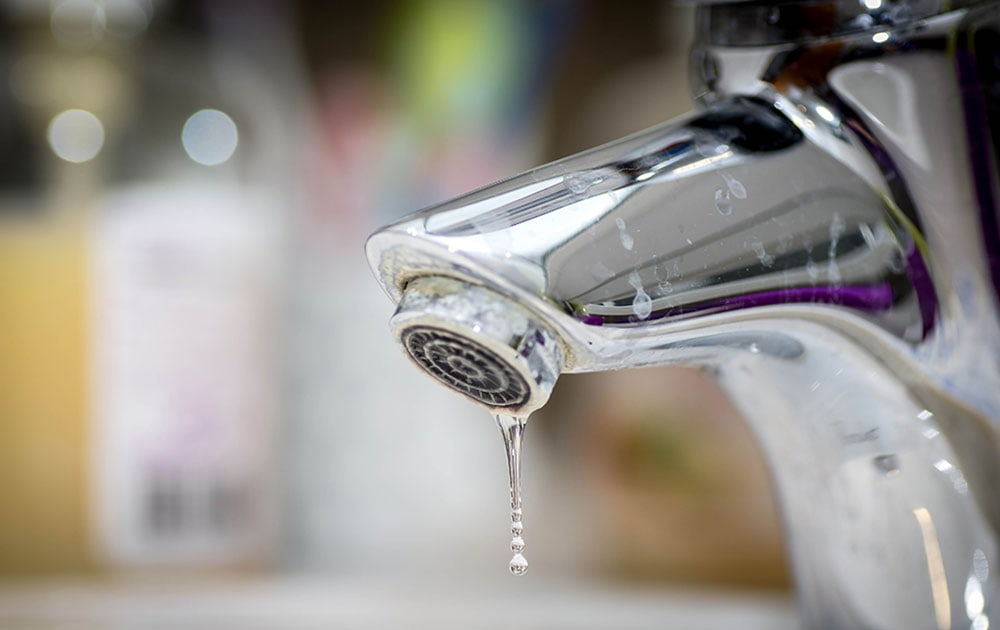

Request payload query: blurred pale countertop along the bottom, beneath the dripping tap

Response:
[0,576,797,630]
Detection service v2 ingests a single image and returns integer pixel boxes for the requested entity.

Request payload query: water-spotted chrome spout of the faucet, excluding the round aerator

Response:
[368,97,936,371]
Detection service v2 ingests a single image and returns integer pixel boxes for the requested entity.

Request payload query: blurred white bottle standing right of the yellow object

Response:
[91,0,294,570]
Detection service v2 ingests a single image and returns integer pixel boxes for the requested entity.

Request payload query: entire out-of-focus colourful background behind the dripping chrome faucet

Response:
[0,0,790,628]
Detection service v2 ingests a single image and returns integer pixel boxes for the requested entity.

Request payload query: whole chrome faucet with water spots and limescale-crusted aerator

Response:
[366,0,1000,629]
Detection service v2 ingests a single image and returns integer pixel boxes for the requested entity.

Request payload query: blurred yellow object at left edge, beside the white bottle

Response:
[0,217,91,575]
